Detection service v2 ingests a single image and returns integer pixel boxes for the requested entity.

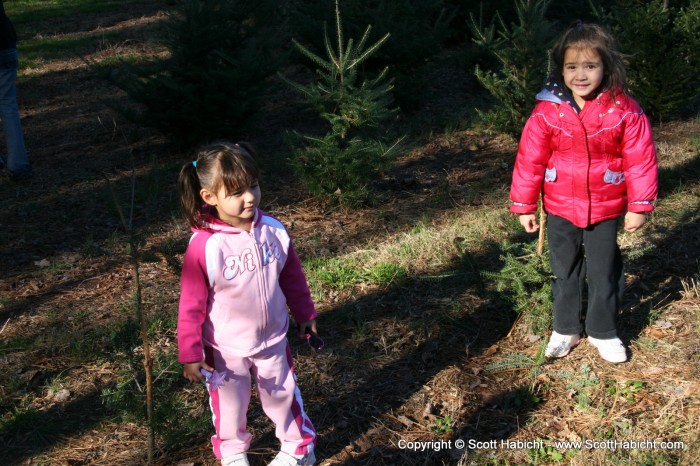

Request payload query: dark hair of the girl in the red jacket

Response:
[550,20,627,93]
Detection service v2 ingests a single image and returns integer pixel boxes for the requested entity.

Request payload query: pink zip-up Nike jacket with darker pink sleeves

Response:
[177,210,317,363]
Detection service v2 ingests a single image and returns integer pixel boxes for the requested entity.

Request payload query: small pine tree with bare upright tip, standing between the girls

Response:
[281,1,398,204]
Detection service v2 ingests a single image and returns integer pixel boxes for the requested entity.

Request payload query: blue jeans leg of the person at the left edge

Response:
[0,49,32,174]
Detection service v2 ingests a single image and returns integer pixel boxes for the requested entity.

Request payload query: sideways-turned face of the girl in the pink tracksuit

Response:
[200,181,261,231]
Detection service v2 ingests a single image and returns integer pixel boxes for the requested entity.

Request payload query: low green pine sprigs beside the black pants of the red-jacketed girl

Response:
[482,242,553,335]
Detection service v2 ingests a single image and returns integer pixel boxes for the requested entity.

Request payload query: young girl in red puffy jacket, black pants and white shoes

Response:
[510,21,658,363]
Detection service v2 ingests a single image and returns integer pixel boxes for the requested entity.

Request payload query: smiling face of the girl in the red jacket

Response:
[562,47,604,108]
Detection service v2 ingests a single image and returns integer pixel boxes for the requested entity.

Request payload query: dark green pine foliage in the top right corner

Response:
[595,0,700,121]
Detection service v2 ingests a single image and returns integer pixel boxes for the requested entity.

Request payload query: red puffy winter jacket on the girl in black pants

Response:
[510,90,658,228]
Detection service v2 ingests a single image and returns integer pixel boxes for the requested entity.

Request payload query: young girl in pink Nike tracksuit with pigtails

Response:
[177,143,317,466]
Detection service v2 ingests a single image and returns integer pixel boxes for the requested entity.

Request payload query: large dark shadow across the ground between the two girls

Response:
[231,238,516,464]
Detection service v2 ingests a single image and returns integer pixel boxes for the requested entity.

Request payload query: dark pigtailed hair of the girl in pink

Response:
[178,142,260,228]
